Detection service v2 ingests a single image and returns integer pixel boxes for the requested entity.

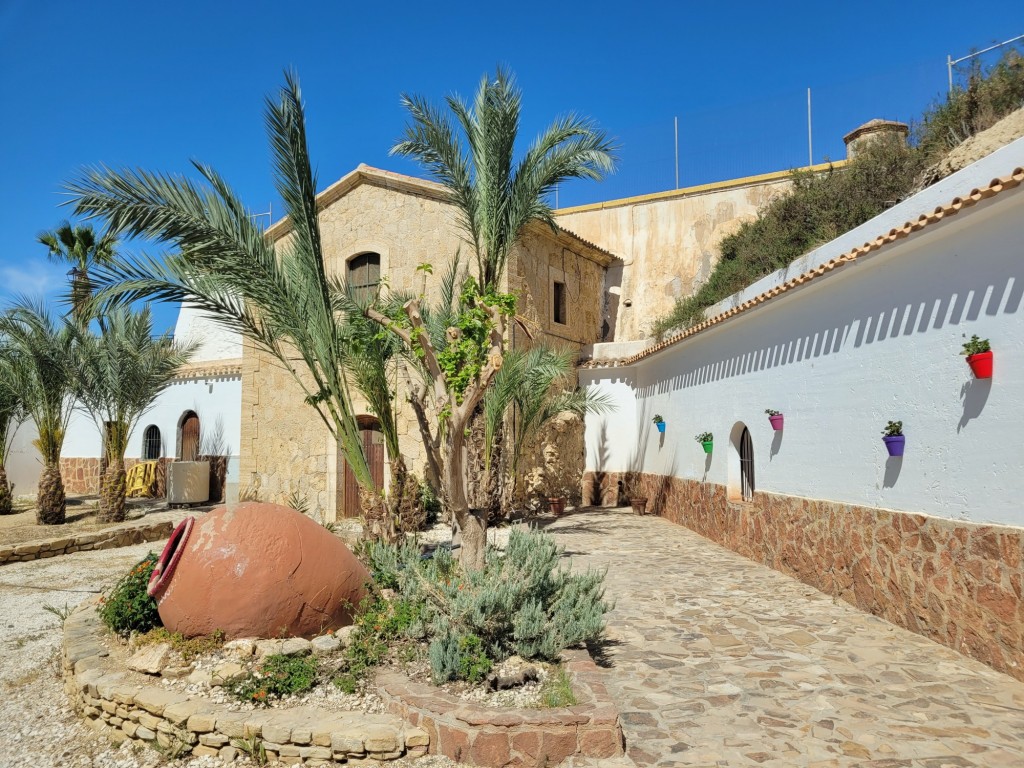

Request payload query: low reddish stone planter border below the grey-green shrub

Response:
[377,650,624,768]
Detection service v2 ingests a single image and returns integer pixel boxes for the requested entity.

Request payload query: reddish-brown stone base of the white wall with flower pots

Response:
[584,472,1024,680]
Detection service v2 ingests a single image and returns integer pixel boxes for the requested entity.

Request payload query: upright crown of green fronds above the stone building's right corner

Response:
[391,68,614,292]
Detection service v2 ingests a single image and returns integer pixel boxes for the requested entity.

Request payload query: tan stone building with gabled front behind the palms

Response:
[241,166,618,519]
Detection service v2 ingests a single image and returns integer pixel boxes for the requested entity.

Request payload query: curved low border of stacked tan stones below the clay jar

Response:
[63,600,429,765]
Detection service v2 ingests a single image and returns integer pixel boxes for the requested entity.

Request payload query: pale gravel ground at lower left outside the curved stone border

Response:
[0,542,458,768]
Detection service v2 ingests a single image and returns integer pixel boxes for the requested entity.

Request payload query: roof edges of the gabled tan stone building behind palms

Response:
[266,163,621,266]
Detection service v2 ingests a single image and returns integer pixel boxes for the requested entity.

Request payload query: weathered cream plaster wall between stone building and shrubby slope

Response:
[557,162,842,341]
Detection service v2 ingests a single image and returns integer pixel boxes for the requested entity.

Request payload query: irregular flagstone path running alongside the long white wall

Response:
[548,510,1024,768]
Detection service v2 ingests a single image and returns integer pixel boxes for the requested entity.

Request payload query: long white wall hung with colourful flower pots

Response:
[580,179,1024,525]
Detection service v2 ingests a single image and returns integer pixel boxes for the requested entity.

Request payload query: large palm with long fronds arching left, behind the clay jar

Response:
[67,73,380,518]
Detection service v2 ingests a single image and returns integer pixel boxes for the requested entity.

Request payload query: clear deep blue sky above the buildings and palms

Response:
[0,0,1024,327]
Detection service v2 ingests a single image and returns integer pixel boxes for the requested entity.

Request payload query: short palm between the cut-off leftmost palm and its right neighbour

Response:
[0,301,77,525]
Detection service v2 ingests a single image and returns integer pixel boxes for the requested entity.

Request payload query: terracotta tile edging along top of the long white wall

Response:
[582,168,1024,368]
